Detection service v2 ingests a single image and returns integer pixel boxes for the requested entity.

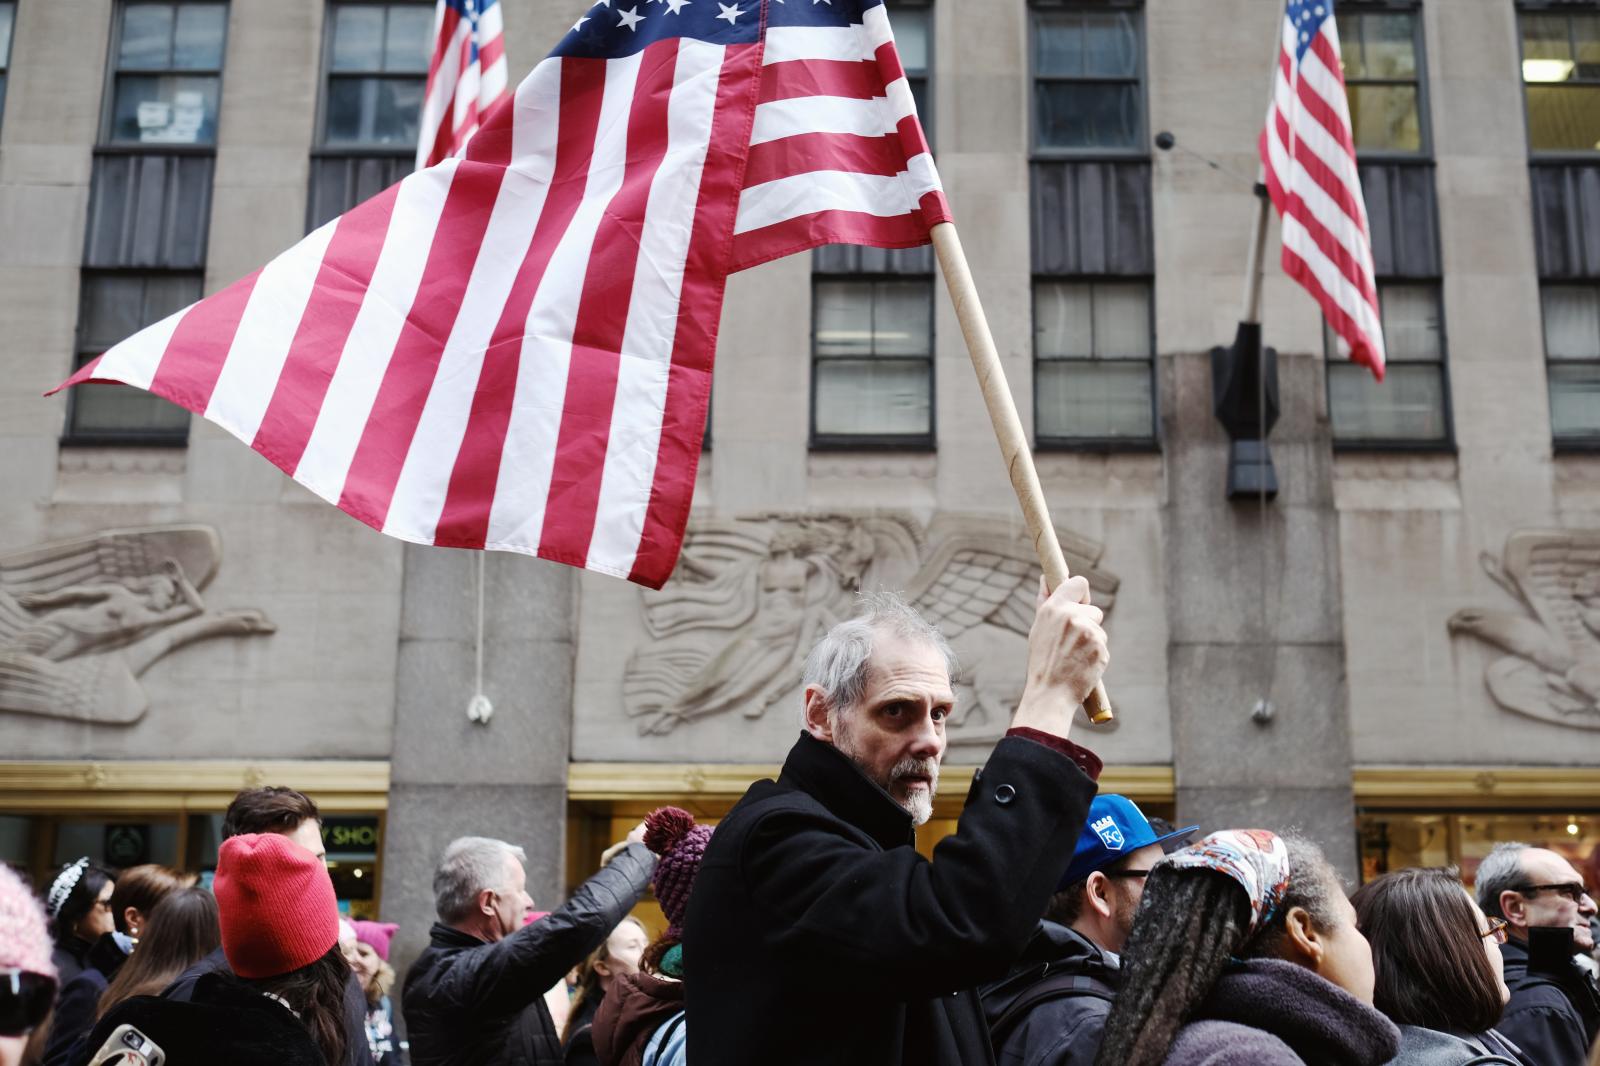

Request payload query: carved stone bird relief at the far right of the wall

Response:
[1446,530,1600,730]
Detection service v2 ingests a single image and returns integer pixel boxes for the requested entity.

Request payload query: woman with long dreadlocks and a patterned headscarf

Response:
[1094,829,1400,1066]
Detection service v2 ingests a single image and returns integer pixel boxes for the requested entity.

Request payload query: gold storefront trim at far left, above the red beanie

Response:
[0,759,389,813]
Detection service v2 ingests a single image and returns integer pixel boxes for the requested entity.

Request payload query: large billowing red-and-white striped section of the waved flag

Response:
[54,37,760,587]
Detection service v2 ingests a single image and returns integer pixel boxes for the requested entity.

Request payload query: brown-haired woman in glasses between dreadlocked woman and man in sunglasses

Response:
[1350,868,1526,1066]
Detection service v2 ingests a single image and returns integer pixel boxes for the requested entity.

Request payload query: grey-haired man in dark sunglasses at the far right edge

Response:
[1477,844,1600,1066]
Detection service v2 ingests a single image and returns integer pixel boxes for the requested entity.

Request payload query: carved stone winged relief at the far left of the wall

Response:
[0,525,277,723]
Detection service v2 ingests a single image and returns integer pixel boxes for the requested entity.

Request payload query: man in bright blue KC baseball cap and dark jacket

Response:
[981,794,1200,1066]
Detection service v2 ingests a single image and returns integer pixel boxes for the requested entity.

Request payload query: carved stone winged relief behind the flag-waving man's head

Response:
[622,514,1118,743]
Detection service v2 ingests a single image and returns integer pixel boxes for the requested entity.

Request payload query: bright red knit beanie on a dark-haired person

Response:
[211,832,339,978]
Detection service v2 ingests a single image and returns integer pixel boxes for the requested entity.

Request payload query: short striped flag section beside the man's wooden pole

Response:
[731,3,952,271]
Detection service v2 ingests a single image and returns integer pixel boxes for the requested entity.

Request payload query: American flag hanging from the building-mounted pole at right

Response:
[1261,0,1384,381]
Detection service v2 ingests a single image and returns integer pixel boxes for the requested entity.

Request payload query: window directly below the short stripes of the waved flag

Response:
[811,277,933,448]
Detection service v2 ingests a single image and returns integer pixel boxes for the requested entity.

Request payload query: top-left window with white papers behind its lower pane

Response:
[104,2,227,144]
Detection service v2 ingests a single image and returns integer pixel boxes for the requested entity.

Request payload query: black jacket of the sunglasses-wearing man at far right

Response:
[1496,940,1600,1066]
